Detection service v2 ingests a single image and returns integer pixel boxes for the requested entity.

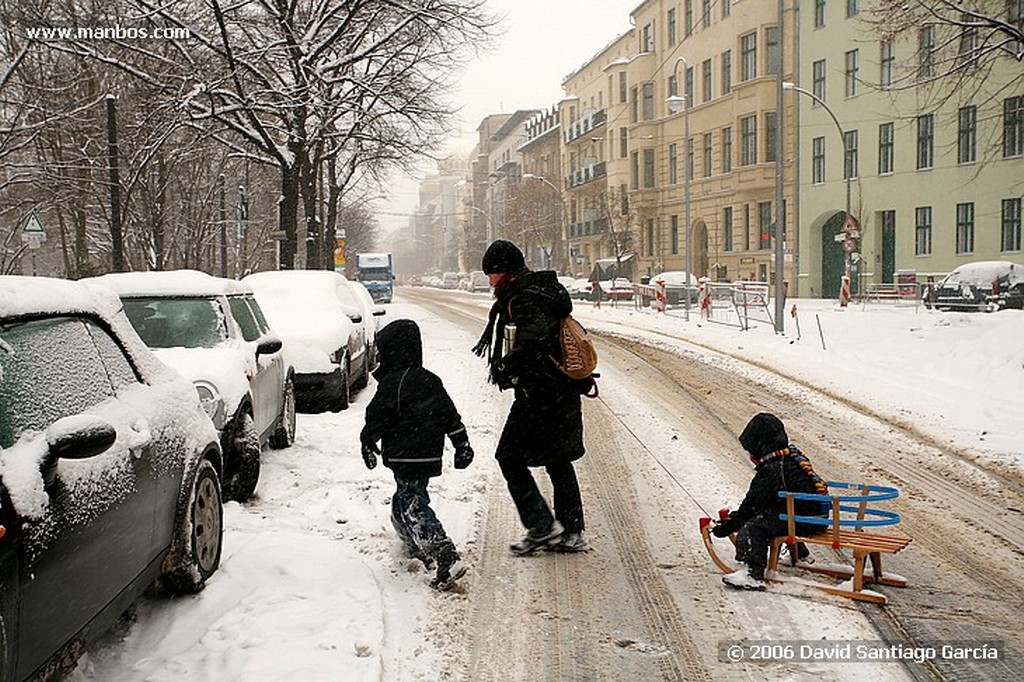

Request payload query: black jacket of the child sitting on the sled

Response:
[727,444,828,532]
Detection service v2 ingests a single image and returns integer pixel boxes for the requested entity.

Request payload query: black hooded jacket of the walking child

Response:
[359,319,468,478]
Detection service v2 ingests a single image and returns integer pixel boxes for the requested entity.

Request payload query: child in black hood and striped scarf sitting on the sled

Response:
[712,413,828,590]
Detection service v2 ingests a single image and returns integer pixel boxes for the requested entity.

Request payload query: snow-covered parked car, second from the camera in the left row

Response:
[90,270,295,502]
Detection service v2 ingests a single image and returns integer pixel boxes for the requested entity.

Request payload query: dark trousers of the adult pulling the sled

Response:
[499,459,584,532]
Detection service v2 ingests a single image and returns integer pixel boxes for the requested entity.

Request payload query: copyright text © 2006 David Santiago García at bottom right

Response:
[718,640,1004,664]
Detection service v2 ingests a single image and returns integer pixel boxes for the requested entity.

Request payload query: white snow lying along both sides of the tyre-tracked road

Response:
[72,289,1024,682]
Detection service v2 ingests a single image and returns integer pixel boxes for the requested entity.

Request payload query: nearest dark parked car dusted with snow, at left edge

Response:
[0,276,223,680]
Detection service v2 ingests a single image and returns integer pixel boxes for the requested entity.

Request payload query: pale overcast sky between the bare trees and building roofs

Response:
[380,0,641,232]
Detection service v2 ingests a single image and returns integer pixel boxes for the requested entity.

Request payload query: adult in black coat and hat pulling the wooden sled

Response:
[474,240,591,554]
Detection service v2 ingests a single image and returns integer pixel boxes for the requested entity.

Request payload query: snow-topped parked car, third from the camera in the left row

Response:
[242,270,370,412]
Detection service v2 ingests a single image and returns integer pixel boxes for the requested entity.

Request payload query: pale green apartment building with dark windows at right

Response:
[792,0,1024,298]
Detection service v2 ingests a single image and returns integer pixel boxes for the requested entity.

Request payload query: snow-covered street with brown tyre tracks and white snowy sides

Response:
[71,289,1024,682]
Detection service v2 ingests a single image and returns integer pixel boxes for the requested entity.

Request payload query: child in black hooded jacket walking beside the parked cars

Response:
[359,319,473,590]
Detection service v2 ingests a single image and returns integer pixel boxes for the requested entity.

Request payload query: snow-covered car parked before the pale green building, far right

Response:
[932,260,1024,311]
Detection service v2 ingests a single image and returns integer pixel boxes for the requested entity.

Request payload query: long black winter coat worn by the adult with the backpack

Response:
[493,269,589,467]
